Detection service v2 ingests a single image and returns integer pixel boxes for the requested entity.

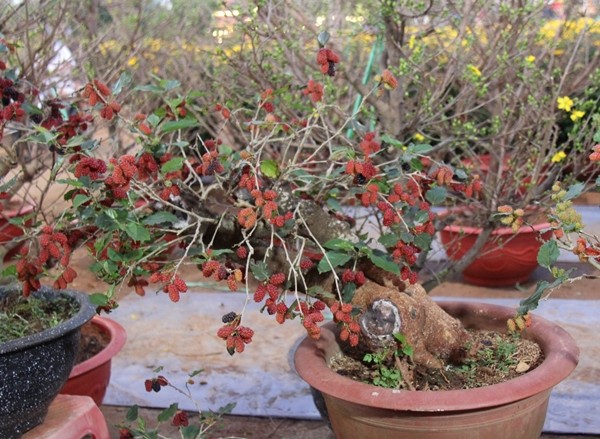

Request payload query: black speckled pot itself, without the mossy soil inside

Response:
[0,287,95,439]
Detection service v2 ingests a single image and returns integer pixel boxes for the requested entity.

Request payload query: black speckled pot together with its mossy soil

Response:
[0,287,95,439]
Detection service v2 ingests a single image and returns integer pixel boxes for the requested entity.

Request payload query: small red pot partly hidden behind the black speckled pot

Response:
[60,316,127,406]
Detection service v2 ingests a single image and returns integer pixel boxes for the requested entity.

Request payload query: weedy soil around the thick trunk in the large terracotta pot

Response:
[330,330,543,390]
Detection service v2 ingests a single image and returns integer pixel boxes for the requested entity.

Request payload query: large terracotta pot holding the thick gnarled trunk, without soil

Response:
[294,302,579,439]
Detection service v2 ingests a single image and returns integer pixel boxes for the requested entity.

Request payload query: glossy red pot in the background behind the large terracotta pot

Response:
[440,219,552,287]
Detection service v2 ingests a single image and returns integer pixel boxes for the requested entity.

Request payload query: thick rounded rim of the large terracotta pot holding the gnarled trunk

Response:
[294,302,579,412]
